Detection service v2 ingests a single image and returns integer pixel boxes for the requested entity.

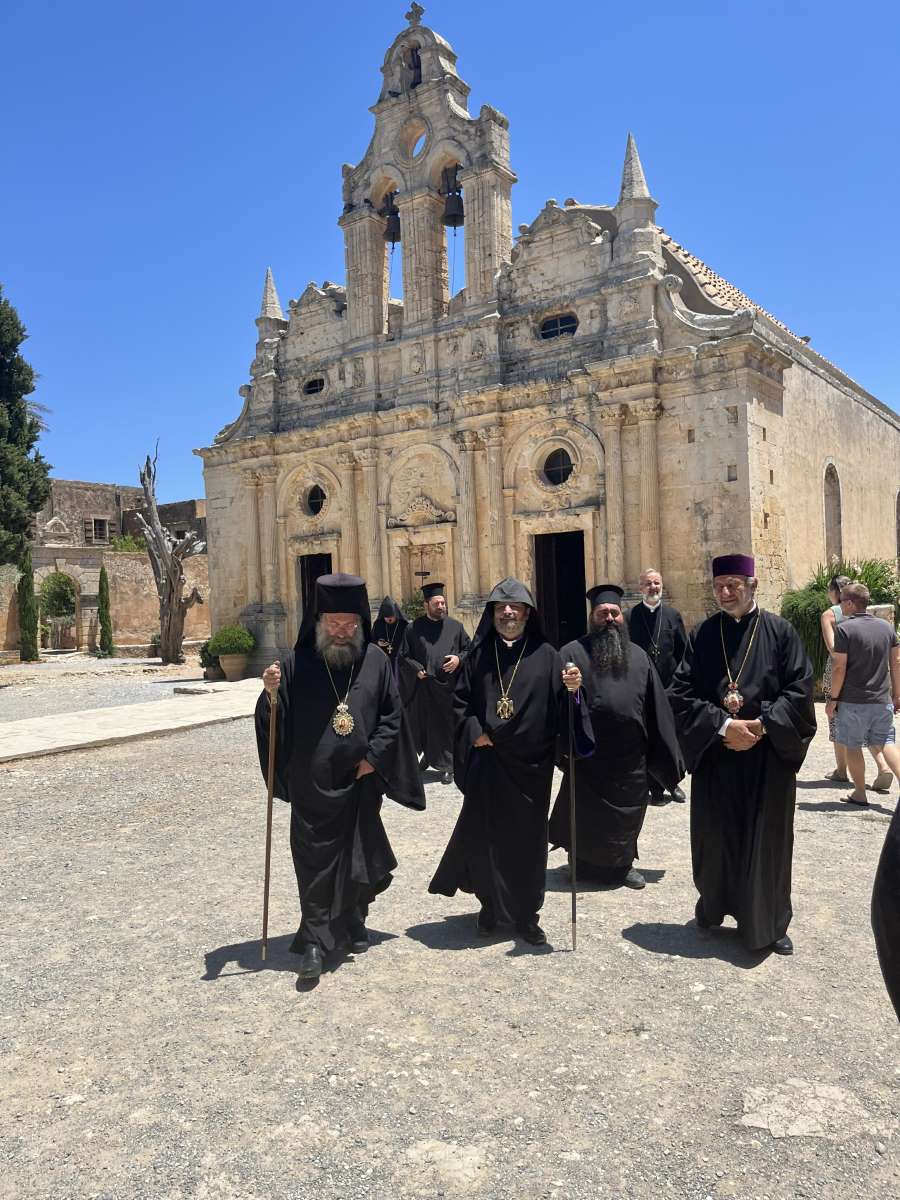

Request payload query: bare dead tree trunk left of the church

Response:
[134,442,206,662]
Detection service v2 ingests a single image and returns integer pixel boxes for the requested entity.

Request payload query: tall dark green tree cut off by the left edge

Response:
[0,288,50,568]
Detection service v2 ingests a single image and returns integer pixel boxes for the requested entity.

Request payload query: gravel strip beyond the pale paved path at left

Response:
[0,655,203,725]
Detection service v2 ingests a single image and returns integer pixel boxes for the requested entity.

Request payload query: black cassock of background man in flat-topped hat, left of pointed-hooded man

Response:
[400,617,470,773]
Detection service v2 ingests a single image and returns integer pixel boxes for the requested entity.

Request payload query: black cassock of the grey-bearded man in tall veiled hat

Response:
[256,646,425,953]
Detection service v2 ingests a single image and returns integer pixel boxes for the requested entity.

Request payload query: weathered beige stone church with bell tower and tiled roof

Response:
[197,5,900,656]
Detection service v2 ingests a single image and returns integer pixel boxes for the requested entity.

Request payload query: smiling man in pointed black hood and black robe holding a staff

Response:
[428,578,581,946]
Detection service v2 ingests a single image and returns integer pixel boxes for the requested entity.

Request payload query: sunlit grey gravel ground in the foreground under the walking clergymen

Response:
[0,705,900,1200]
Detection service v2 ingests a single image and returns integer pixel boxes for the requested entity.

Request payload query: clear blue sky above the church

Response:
[0,0,900,499]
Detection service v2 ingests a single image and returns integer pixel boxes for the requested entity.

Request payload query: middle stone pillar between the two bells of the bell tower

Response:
[397,187,449,330]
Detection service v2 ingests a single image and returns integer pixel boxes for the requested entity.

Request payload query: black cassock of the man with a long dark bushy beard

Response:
[550,636,684,882]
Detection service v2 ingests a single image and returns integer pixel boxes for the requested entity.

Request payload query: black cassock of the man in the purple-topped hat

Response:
[668,608,816,949]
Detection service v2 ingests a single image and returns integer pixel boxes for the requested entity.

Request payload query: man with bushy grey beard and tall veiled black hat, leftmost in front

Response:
[256,575,425,979]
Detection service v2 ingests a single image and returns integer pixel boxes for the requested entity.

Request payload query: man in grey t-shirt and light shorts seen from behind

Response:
[826,583,900,805]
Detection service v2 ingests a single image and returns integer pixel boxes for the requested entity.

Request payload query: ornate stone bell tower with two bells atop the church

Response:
[340,4,516,344]
